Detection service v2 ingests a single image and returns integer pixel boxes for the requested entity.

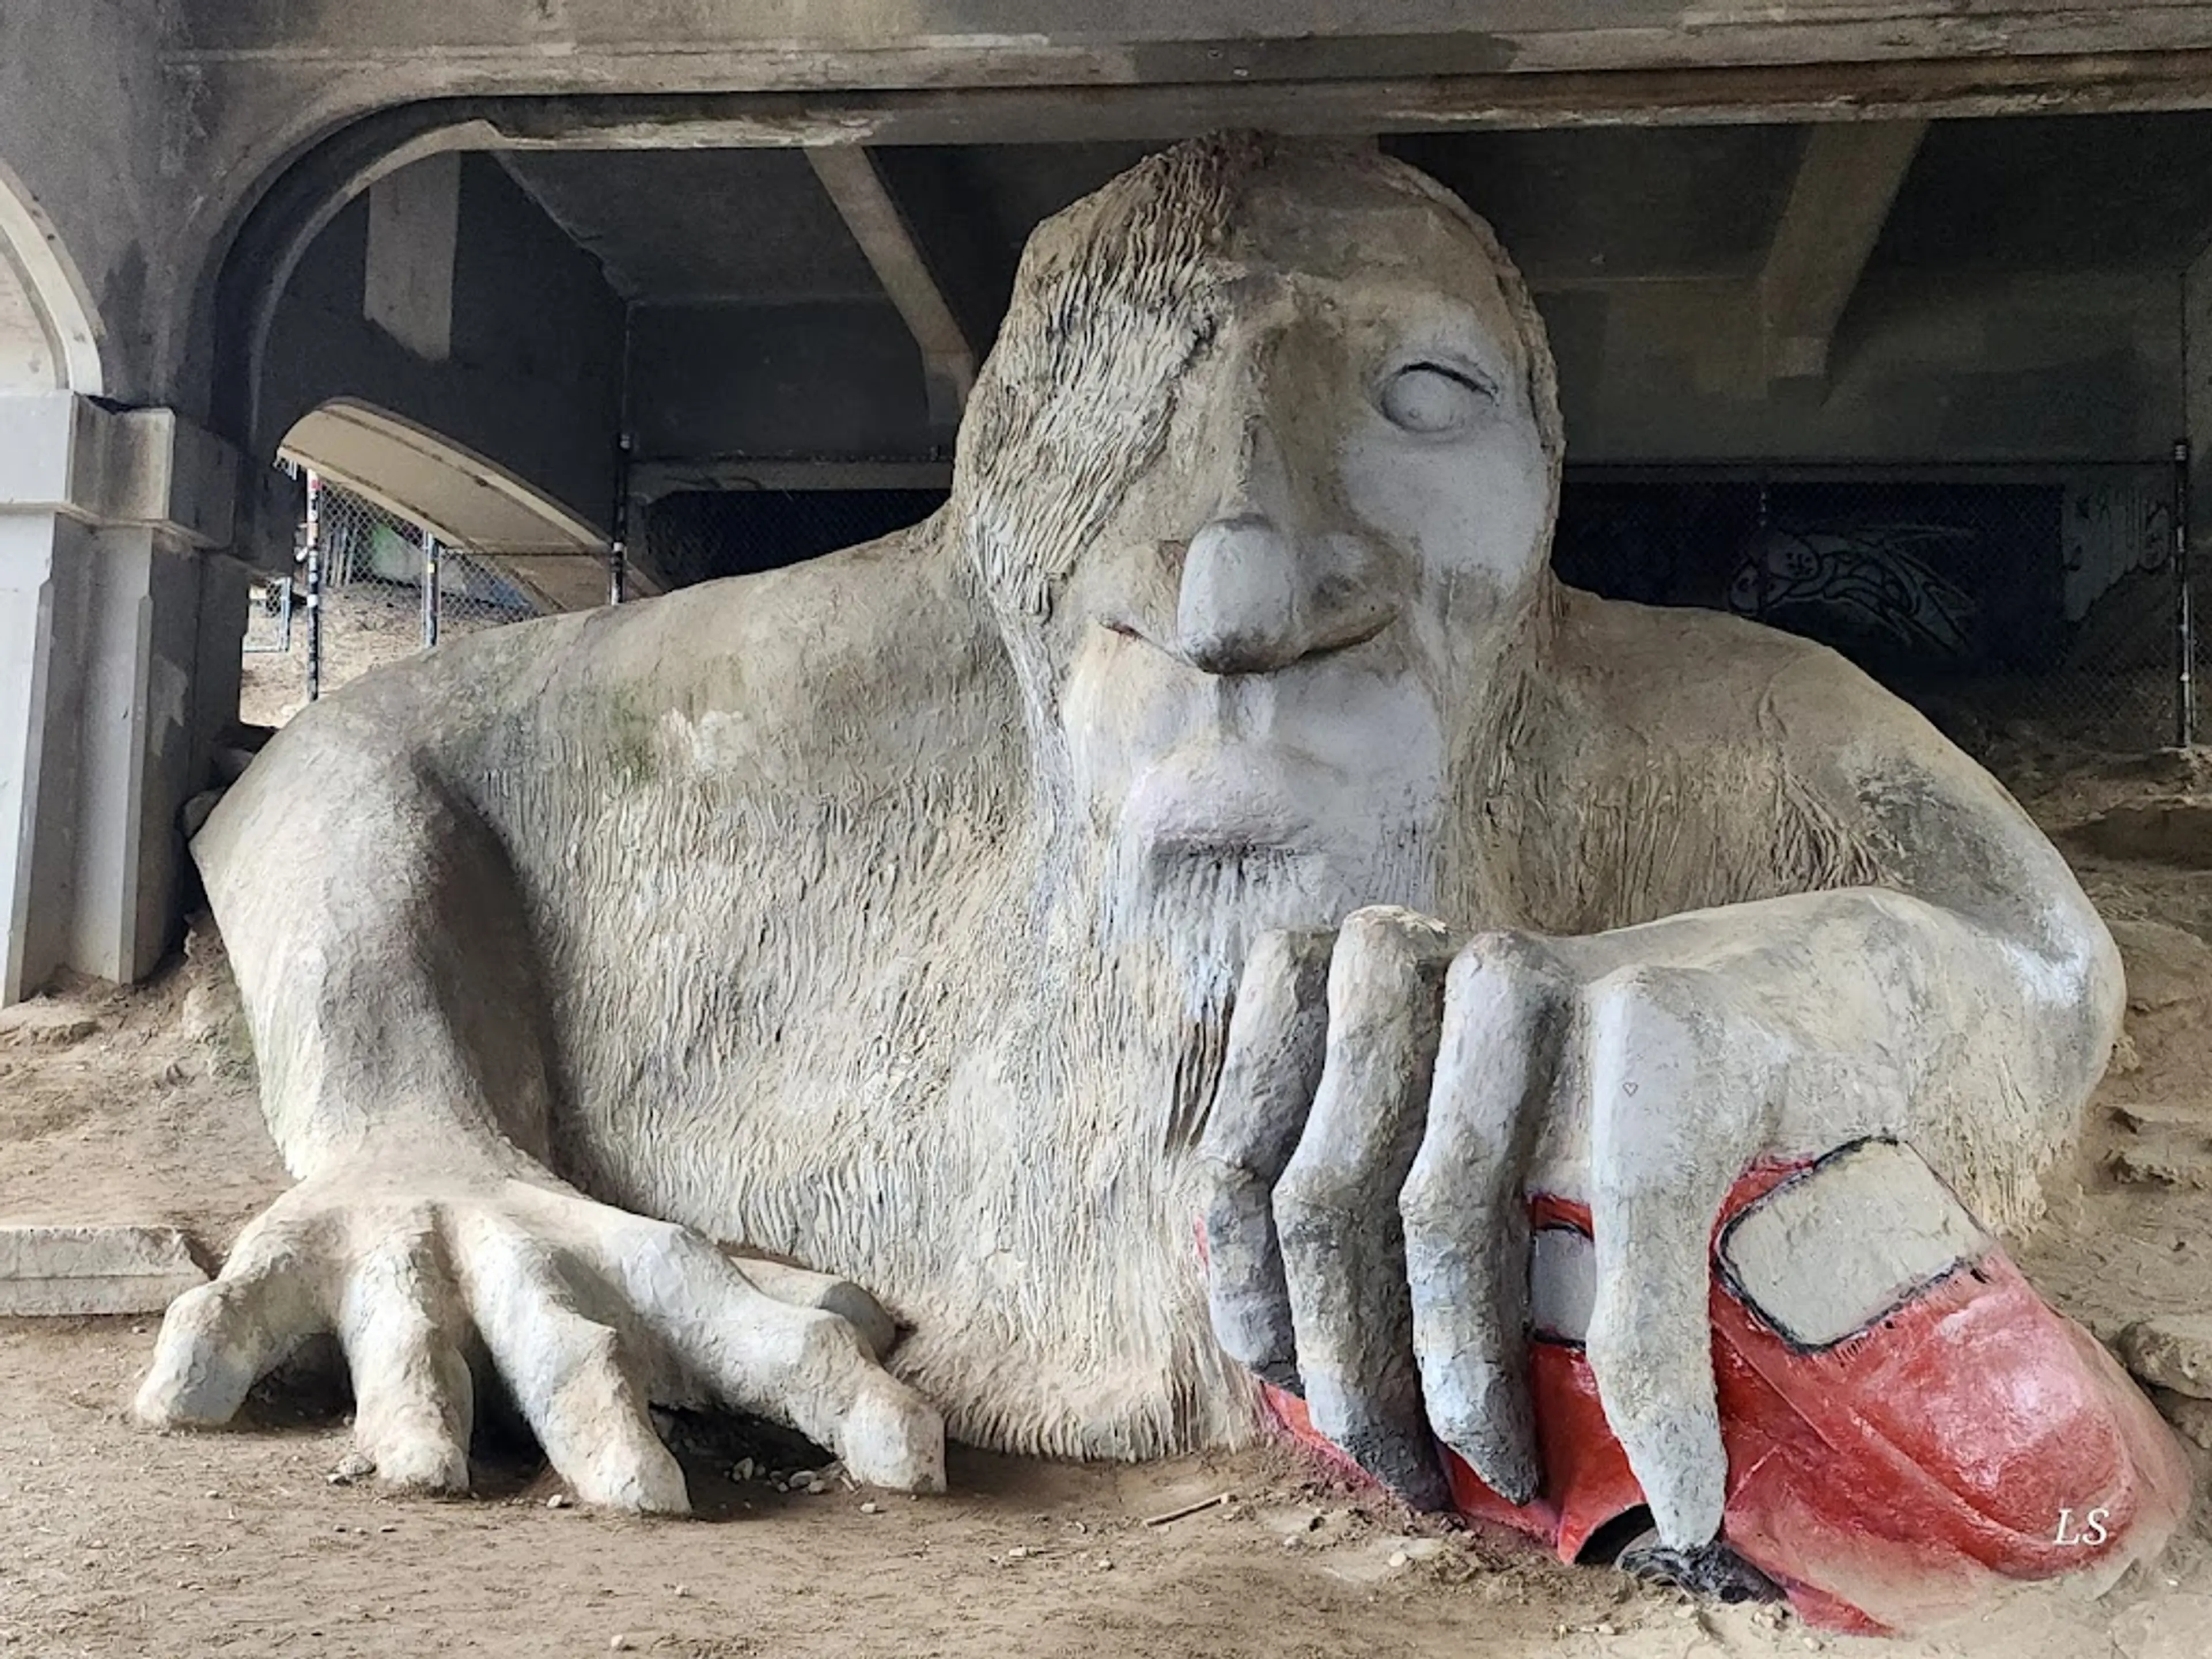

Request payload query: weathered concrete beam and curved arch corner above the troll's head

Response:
[17,0,2212,422]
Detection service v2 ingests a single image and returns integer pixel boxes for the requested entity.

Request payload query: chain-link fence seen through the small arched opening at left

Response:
[239,474,542,726]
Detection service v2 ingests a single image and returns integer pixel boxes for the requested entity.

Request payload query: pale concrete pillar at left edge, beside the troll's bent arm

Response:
[0,392,245,1002]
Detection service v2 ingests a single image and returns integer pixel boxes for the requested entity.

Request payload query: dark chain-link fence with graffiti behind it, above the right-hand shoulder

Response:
[1553,464,2203,759]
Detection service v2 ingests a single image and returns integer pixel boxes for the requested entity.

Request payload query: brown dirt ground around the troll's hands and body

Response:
[0,734,2212,1659]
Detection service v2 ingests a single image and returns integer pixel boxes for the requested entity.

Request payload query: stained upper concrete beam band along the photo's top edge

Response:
[168,0,2212,86]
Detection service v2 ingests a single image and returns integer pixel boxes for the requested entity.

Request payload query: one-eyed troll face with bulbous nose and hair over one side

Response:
[956,139,1559,973]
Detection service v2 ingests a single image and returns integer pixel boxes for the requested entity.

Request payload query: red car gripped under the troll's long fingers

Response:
[1267,1139,2190,1635]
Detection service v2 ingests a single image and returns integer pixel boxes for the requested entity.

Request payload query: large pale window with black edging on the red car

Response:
[1721,1141,1991,1349]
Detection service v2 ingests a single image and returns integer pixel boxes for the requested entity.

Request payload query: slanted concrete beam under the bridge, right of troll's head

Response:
[1759,122,1927,382]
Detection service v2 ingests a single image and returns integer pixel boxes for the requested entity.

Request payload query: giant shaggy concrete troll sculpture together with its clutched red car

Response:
[139,139,2181,1628]
